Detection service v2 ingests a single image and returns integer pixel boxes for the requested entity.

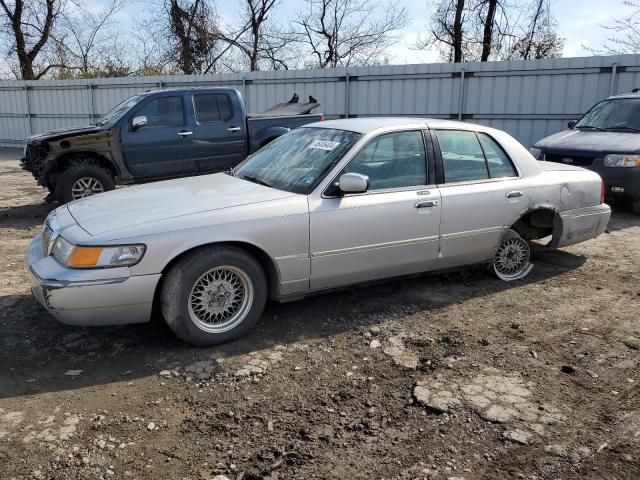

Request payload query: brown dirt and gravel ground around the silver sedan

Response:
[0,155,640,480]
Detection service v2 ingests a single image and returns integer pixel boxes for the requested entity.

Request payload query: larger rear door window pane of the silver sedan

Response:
[436,130,489,183]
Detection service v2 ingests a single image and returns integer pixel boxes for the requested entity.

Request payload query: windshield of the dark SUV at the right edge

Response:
[575,98,640,132]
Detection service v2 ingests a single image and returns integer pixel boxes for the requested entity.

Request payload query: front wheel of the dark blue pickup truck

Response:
[56,163,116,203]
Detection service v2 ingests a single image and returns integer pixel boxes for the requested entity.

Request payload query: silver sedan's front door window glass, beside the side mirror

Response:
[342,131,427,190]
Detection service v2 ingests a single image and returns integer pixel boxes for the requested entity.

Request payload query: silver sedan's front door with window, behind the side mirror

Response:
[309,130,440,290]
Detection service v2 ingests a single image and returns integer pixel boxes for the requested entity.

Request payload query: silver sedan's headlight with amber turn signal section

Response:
[51,236,147,268]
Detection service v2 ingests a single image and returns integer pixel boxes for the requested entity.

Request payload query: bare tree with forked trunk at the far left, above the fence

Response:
[0,0,62,80]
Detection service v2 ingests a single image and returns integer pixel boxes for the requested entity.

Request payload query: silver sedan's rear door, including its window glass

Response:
[433,130,529,268]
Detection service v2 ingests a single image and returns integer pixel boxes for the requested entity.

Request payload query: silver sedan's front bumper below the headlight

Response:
[26,235,160,326]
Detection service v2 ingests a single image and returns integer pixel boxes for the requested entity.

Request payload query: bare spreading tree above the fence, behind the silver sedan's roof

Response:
[294,0,407,68]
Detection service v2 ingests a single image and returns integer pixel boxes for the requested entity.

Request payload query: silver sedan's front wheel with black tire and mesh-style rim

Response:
[160,247,268,347]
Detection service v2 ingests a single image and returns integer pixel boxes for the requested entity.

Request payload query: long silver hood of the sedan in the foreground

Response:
[67,173,295,235]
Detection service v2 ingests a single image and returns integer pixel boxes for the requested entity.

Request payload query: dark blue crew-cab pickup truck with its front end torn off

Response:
[21,87,322,203]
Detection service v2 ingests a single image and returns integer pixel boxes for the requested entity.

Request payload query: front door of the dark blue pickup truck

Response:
[121,95,193,177]
